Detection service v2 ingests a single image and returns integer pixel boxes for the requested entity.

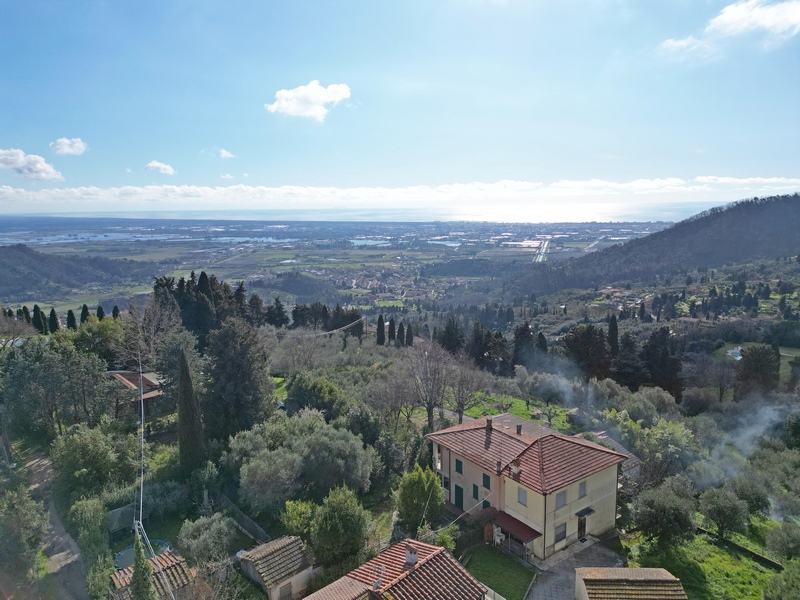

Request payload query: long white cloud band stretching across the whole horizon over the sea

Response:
[0,175,800,223]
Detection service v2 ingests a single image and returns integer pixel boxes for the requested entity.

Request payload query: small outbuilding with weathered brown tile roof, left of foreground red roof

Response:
[239,535,314,600]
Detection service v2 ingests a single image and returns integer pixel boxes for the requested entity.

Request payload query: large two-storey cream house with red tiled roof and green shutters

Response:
[426,414,627,560]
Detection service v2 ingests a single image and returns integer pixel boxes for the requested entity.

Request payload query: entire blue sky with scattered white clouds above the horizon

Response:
[0,0,800,222]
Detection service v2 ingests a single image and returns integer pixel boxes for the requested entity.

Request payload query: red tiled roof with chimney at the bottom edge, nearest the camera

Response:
[306,540,486,600]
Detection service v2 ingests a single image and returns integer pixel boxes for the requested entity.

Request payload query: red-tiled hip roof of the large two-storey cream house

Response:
[426,415,627,494]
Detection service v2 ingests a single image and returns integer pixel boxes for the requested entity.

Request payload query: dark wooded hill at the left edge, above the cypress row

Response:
[0,244,159,303]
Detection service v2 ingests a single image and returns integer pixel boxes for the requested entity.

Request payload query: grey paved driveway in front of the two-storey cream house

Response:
[525,542,625,600]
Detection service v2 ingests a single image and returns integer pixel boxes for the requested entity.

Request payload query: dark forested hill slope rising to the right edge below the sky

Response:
[510,194,800,293]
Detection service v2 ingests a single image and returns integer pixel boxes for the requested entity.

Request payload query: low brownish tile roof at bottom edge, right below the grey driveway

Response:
[575,567,687,600]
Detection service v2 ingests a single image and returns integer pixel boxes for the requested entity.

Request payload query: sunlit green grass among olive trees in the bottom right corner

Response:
[623,535,776,600]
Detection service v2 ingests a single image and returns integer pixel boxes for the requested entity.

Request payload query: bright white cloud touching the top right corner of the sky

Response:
[706,0,800,37]
